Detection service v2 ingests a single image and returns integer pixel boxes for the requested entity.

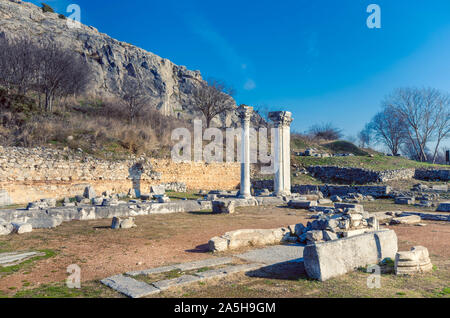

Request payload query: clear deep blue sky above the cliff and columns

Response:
[28,0,450,140]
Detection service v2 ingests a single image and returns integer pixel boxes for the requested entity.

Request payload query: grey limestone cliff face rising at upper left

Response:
[0,0,236,124]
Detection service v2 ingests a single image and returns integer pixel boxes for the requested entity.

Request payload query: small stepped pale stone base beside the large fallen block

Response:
[395,246,433,275]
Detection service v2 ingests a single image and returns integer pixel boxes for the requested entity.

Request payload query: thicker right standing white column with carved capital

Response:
[269,111,293,196]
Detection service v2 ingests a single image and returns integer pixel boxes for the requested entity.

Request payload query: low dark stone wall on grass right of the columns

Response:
[306,166,415,184]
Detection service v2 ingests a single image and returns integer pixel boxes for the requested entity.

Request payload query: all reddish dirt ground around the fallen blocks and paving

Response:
[0,203,450,297]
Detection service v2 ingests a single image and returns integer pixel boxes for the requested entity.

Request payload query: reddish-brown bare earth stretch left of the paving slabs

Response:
[0,207,307,292]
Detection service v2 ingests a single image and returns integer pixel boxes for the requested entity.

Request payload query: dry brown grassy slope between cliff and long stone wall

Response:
[0,89,188,158]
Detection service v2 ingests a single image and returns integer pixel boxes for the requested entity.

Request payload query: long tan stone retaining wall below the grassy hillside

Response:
[0,147,240,204]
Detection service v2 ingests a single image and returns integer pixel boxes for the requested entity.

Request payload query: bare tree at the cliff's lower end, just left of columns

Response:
[192,79,235,128]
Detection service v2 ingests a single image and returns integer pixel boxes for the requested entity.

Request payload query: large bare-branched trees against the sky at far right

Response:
[358,88,450,163]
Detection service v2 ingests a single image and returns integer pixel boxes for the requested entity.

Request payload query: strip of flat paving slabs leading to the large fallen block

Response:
[101,244,304,298]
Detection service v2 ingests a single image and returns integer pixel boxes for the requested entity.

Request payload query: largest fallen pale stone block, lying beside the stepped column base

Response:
[303,230,398,281]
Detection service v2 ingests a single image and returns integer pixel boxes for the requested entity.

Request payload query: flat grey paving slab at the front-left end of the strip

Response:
[101,275,161,298]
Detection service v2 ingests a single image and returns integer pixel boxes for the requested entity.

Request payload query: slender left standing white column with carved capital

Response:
[238,105,253,198]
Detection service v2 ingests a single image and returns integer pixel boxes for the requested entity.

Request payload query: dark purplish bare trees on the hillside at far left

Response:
[0,37,90,112]
